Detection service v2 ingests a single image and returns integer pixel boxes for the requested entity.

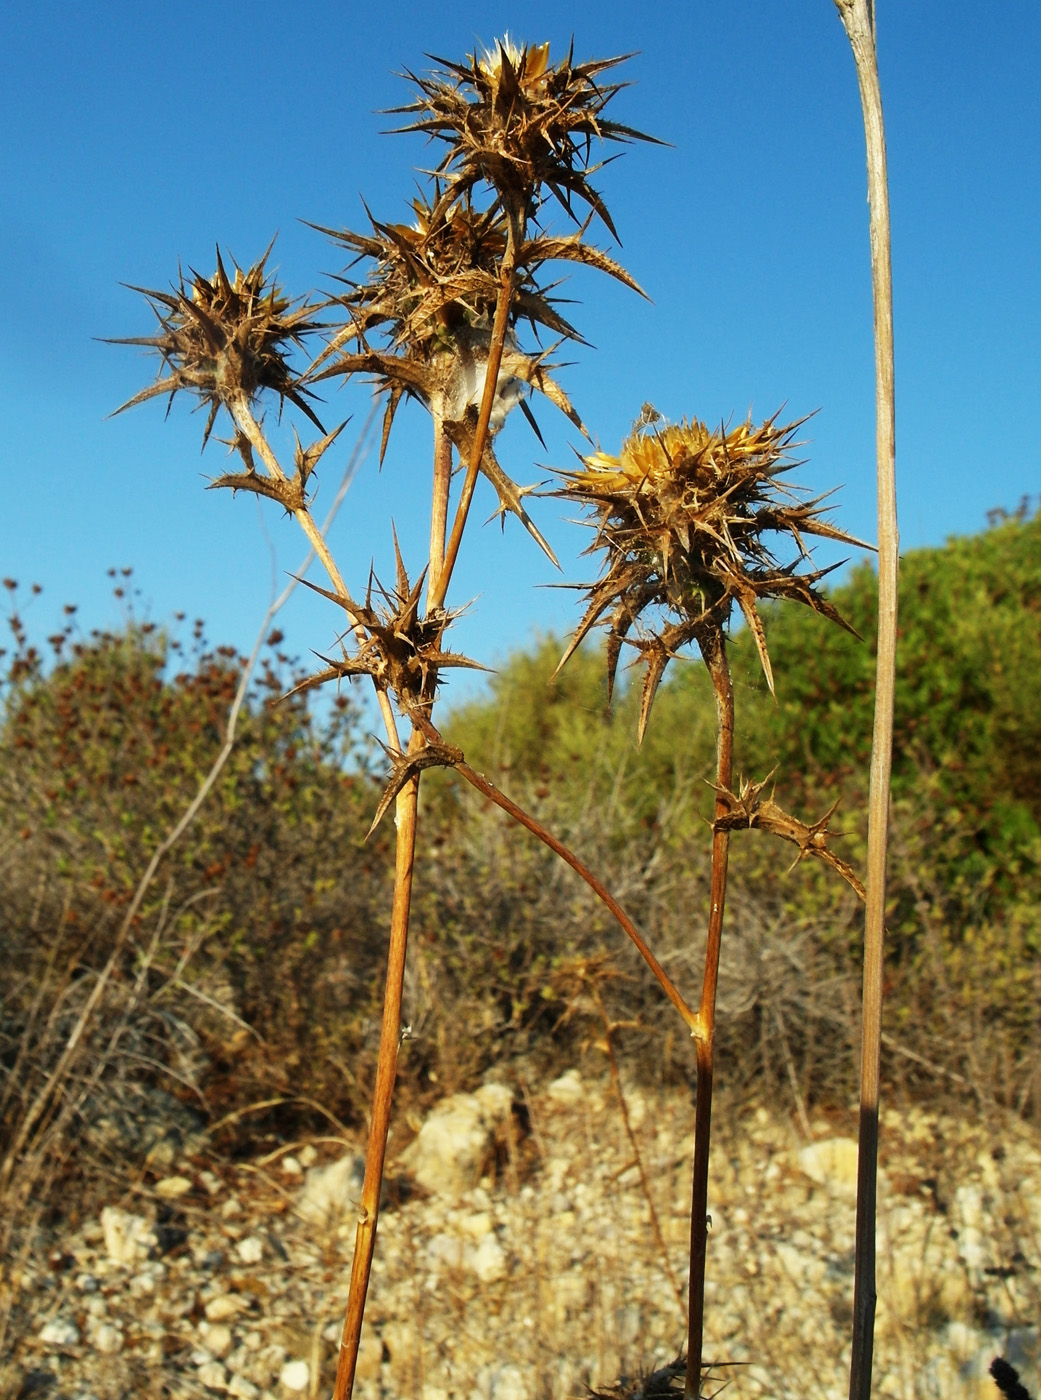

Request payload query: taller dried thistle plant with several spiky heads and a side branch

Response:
[114,39,697,1400]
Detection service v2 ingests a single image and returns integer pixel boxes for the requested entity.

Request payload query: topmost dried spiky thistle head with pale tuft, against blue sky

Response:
[396,36,653,238]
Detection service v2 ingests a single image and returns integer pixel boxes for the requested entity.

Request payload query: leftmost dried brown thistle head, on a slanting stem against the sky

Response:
[116,248,325,442]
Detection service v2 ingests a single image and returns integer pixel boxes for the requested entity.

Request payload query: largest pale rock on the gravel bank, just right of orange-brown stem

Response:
[400,1084,514,1197]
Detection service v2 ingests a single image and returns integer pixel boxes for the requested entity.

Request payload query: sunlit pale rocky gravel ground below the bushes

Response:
[0,1070,1041,1400]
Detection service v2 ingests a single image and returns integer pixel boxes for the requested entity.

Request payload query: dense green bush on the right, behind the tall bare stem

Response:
[445,511,1041,1112]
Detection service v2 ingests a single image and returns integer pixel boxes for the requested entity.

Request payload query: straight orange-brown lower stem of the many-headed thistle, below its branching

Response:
[333,761,423,1400]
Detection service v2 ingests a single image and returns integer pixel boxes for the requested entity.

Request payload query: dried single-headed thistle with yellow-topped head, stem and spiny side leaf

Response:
[561,405,861,1400]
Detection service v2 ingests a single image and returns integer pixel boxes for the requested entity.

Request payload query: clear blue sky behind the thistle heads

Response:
[0,0,1041,711]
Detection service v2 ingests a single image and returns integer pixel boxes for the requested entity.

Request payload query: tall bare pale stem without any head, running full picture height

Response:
[835,0,900,1400]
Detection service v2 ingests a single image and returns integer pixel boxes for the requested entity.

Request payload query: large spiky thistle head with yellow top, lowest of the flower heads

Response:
[560,405,861,739]
